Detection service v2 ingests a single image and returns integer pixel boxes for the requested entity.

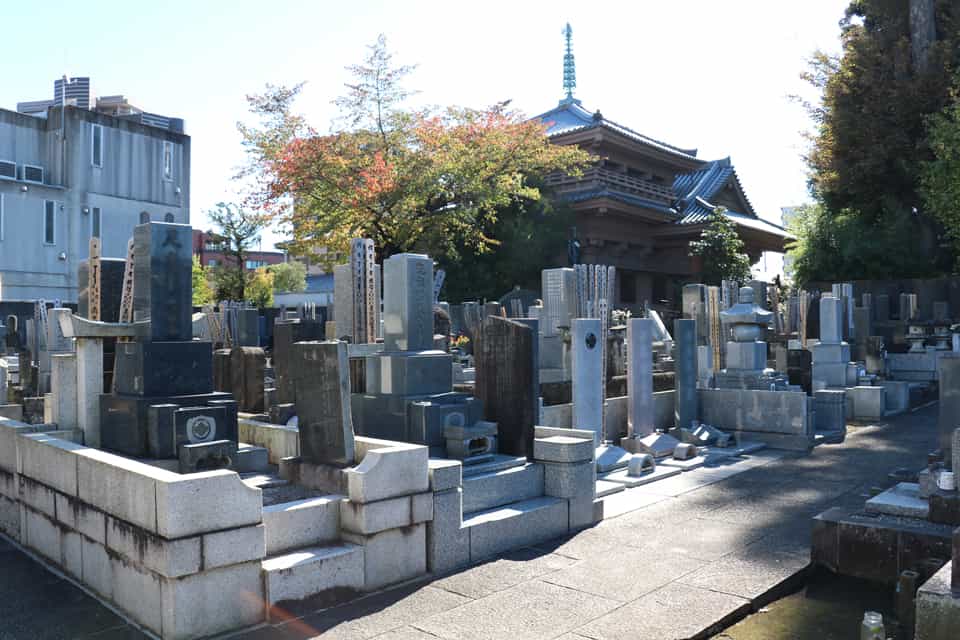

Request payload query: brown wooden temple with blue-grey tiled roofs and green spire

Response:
[537,25,791,308]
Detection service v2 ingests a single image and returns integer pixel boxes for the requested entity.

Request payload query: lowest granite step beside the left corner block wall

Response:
[260,542,363,607]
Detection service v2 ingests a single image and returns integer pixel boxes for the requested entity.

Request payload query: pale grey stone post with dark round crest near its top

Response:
[571,318,603,444]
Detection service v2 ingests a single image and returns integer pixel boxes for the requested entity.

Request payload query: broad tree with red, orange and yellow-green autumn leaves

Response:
[241,36,591,261]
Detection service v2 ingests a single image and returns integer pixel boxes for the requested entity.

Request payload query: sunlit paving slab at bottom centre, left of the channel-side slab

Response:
[414,580,620,640]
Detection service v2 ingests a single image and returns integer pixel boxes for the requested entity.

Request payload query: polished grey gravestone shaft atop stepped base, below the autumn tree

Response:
[383,253,433,351]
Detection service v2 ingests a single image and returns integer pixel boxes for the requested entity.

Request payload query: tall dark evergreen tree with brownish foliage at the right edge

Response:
[803,0,960,279]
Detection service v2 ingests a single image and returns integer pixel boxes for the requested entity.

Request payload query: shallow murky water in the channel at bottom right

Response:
[713,570,907,640]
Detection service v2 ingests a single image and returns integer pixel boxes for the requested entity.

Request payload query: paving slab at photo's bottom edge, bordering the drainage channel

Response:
[576,583,750,640]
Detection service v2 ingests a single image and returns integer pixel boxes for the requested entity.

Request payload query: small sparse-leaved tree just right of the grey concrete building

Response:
[207,202,267,300]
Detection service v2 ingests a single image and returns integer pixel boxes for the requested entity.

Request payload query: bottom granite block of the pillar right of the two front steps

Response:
[342,520,424,591]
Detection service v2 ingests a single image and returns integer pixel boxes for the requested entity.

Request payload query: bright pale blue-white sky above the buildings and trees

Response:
[0,0,847,248]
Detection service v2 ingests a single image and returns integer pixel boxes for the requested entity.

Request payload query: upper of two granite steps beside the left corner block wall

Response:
[263,495,344,556]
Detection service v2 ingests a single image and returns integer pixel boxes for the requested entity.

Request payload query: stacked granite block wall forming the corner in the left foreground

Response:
[0,412,266,639]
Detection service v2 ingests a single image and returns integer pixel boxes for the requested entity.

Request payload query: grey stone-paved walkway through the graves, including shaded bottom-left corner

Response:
[0,405,937,640]
